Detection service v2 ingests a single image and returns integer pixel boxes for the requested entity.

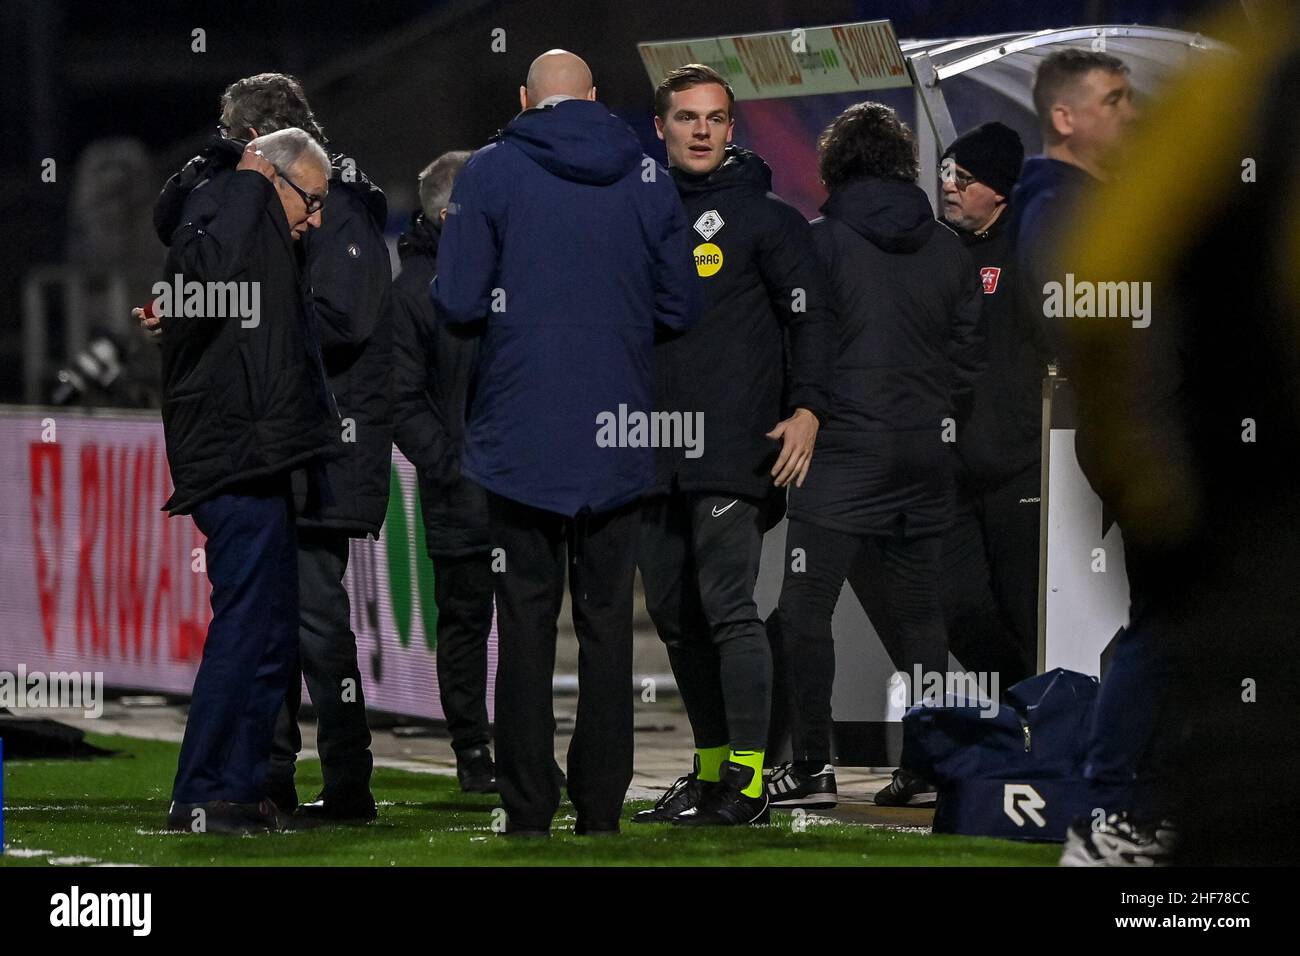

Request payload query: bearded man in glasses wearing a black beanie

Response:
[940,122,1043,687]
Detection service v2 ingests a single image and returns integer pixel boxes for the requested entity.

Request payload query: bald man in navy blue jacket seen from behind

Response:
[432,49,699,835]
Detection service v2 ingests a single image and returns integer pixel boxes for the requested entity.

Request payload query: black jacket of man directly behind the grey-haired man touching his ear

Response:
[298,157,393,537]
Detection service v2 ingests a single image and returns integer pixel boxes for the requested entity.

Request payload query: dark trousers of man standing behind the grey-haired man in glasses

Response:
[268,528,373,800]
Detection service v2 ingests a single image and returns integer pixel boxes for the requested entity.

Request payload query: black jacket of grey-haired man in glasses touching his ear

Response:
[153,139,337,514]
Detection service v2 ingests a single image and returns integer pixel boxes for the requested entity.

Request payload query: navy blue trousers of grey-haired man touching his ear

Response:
[172,479,298,804]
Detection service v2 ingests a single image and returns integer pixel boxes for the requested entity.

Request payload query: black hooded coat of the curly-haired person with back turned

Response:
[789,178,984,537]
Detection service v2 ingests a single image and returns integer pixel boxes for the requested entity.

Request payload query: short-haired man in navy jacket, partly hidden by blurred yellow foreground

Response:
[1010,49,1178,866]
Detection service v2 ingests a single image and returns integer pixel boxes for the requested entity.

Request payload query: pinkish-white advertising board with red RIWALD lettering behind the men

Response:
[0,407,497,718]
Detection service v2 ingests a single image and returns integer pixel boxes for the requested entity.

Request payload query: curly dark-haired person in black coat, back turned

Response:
[774,103,983,800]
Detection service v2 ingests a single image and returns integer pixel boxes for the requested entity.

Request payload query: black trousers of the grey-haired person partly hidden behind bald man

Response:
[433,551,495,754]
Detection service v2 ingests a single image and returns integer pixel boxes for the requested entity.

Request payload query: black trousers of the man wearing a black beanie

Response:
[940,463,1040,688]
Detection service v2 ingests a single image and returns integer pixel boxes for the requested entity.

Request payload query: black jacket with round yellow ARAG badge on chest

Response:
[654,146,835,498]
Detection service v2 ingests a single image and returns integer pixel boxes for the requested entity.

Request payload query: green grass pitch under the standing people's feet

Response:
[0,735,1060,866]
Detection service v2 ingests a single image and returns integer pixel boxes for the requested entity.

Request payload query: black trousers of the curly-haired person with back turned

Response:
[776,520,948,763]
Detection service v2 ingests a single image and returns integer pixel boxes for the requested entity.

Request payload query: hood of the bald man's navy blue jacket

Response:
[502,100,644,186]
